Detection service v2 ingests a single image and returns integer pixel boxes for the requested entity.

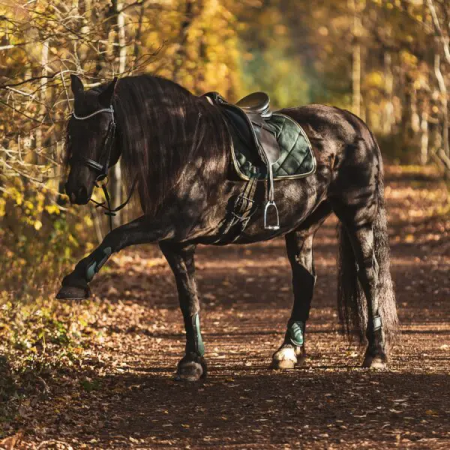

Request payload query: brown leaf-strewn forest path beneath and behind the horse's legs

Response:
[0,167,450,449]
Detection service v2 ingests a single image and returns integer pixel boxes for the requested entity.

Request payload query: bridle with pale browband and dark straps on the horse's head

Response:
[70,105,137,231]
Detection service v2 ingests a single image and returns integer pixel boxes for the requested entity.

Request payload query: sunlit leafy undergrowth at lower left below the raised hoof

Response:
[0,296,107,438]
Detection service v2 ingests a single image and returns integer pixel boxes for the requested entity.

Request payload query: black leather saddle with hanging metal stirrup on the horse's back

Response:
[204,92,281,230]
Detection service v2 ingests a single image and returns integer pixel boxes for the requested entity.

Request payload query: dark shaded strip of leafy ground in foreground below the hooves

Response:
[34,367,450,448]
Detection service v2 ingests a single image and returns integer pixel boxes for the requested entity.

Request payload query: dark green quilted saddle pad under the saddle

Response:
[231,112,316,180]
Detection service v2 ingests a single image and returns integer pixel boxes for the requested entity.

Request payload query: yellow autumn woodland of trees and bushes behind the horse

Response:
[0,0,450,446]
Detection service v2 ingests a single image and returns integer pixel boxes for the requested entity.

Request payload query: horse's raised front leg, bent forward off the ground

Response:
[56,216,167,300]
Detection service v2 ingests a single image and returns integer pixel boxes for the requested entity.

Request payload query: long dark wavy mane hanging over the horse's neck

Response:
[114,75,231,214]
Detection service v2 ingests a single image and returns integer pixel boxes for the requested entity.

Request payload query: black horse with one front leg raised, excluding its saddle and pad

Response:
[58,75,397,380]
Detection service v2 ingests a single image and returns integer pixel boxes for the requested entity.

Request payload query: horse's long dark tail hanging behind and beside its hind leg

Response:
[338,158,398,350]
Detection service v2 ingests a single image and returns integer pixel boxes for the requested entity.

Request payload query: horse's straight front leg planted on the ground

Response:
[159,241,207,381]
